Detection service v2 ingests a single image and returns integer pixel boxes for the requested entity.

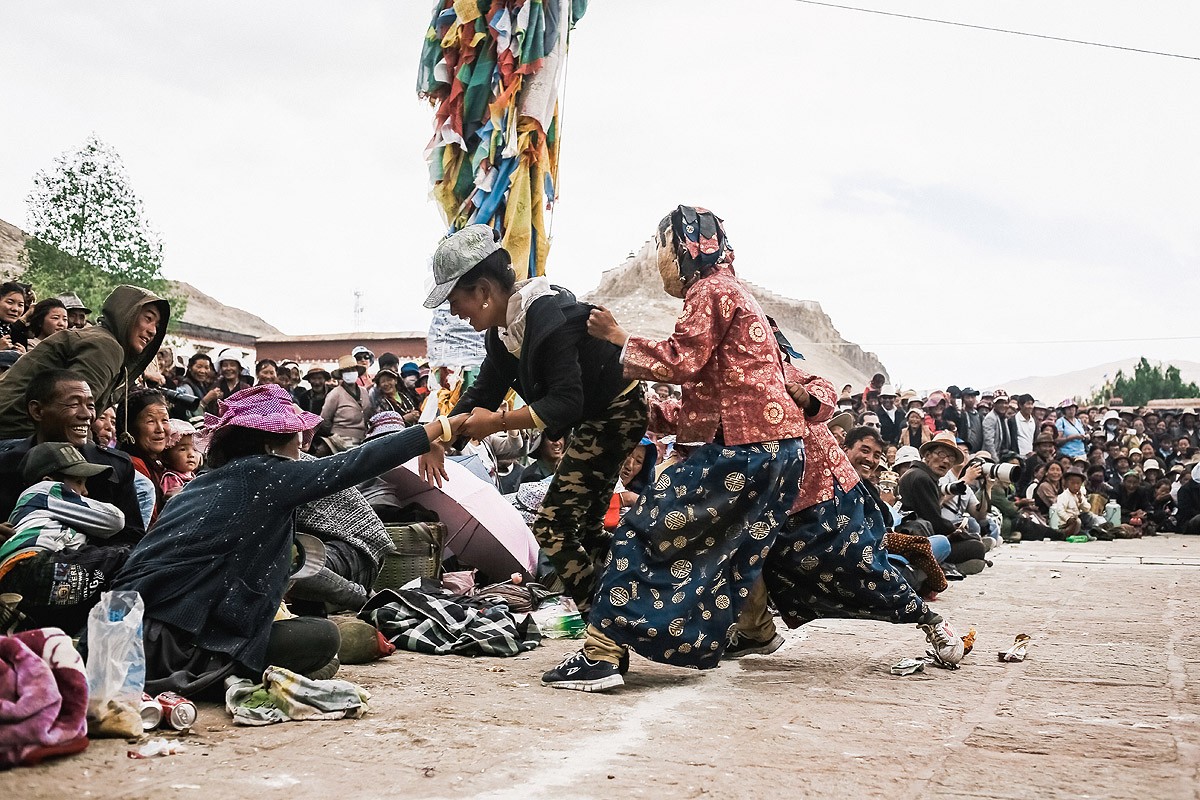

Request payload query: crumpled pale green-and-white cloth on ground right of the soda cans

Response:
[226,667,371,726]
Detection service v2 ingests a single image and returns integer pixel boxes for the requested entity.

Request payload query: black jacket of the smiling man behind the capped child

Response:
[0,437,145,545]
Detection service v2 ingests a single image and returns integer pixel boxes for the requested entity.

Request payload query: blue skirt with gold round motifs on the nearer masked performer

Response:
[589,439,804,669]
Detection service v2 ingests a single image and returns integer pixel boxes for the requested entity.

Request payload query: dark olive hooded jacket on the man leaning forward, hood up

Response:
[0,285,170,439]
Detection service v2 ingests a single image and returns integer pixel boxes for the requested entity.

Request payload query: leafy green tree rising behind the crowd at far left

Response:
[23,134,182,319]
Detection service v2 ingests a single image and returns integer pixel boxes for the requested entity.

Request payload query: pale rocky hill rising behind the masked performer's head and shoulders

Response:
[584,242,887,389]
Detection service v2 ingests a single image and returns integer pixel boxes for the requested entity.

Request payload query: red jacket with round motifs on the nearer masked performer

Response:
[624,265,806,445]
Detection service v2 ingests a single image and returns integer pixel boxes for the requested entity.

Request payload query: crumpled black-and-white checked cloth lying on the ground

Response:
[359,589,541,656]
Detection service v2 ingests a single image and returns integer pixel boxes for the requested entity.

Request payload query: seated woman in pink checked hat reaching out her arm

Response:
[113,384,466,697]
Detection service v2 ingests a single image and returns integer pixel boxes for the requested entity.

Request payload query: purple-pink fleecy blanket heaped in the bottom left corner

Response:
[0,627,88,770]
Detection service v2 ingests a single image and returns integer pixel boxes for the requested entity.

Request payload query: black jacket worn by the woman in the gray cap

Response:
[451,287,630,439]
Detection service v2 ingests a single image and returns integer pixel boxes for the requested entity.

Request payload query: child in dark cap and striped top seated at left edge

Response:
[0,441,128,634]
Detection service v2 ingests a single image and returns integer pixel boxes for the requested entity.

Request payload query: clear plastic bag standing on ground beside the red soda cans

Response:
[88,591,146,738]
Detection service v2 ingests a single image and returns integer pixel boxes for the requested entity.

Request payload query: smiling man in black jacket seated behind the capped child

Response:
[0,369,145,545]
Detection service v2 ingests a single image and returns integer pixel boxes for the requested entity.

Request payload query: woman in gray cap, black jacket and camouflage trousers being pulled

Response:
[422,224,647,610]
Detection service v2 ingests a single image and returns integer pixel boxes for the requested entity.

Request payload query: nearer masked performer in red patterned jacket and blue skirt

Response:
[542,206,809,691]
